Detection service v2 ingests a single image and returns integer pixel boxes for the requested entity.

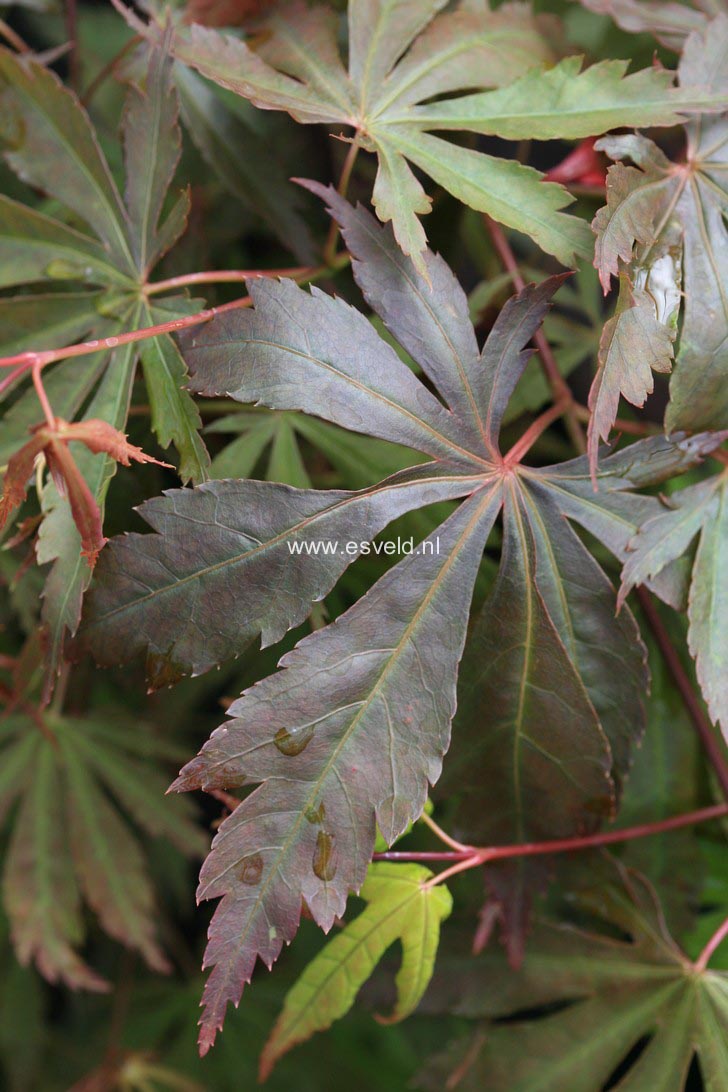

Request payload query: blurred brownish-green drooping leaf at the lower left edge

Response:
[0,714,206,990]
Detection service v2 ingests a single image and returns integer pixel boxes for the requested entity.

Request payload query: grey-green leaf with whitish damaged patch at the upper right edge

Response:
[589,15,728,465]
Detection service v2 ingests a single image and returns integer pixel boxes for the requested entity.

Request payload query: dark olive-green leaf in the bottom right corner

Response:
[417,866,728,1092]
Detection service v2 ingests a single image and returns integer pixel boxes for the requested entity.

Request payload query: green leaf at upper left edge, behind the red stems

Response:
[0,42,210,695]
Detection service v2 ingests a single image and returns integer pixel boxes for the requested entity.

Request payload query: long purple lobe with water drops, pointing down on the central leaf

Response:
[174,486,500,1053]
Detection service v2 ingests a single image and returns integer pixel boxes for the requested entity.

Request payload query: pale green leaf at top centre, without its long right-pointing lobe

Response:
[115,0,598,271]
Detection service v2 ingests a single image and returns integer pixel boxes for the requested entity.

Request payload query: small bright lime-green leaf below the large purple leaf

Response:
[260,862,452,1080]
